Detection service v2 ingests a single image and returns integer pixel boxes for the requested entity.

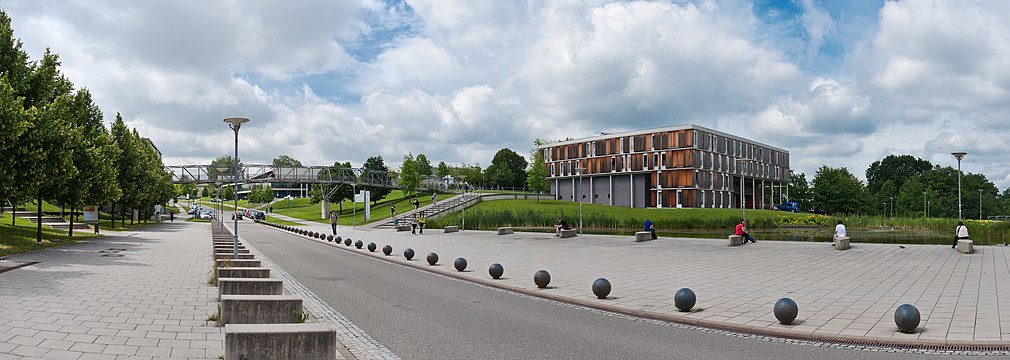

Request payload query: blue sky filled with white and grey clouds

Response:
[0,0,1010,189]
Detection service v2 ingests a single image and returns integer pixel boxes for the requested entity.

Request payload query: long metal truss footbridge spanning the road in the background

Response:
[165,164,398,188]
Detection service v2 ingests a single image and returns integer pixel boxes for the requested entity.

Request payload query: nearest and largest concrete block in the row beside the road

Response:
[224,323,336,360]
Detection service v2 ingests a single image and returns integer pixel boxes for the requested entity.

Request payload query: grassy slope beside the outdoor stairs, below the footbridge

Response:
[274,190,455,226]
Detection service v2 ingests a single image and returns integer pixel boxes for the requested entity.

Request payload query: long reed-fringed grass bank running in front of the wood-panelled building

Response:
[428,200,1010,245]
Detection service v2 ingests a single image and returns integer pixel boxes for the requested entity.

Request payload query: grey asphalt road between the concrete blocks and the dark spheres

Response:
[241,221,978,360]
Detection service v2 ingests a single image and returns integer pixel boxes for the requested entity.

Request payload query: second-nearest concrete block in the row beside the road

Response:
[221,295,302,324]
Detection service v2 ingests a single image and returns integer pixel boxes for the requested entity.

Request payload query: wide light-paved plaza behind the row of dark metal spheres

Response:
[280,224,1010,345]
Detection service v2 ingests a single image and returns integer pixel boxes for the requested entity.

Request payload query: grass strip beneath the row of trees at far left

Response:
[0,213,98,257]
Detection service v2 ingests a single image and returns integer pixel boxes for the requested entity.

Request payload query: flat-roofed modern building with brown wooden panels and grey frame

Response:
[538,124,789,208]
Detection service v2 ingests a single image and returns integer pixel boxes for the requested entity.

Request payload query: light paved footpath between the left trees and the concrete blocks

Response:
[0,220,224,360]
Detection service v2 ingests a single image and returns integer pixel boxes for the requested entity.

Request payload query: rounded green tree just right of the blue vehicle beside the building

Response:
[812,166,870,213]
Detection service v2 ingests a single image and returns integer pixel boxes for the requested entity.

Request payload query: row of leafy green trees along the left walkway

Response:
[0,10,174,240]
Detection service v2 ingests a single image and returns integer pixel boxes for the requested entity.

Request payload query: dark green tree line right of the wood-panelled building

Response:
[789,155,1010,218]
